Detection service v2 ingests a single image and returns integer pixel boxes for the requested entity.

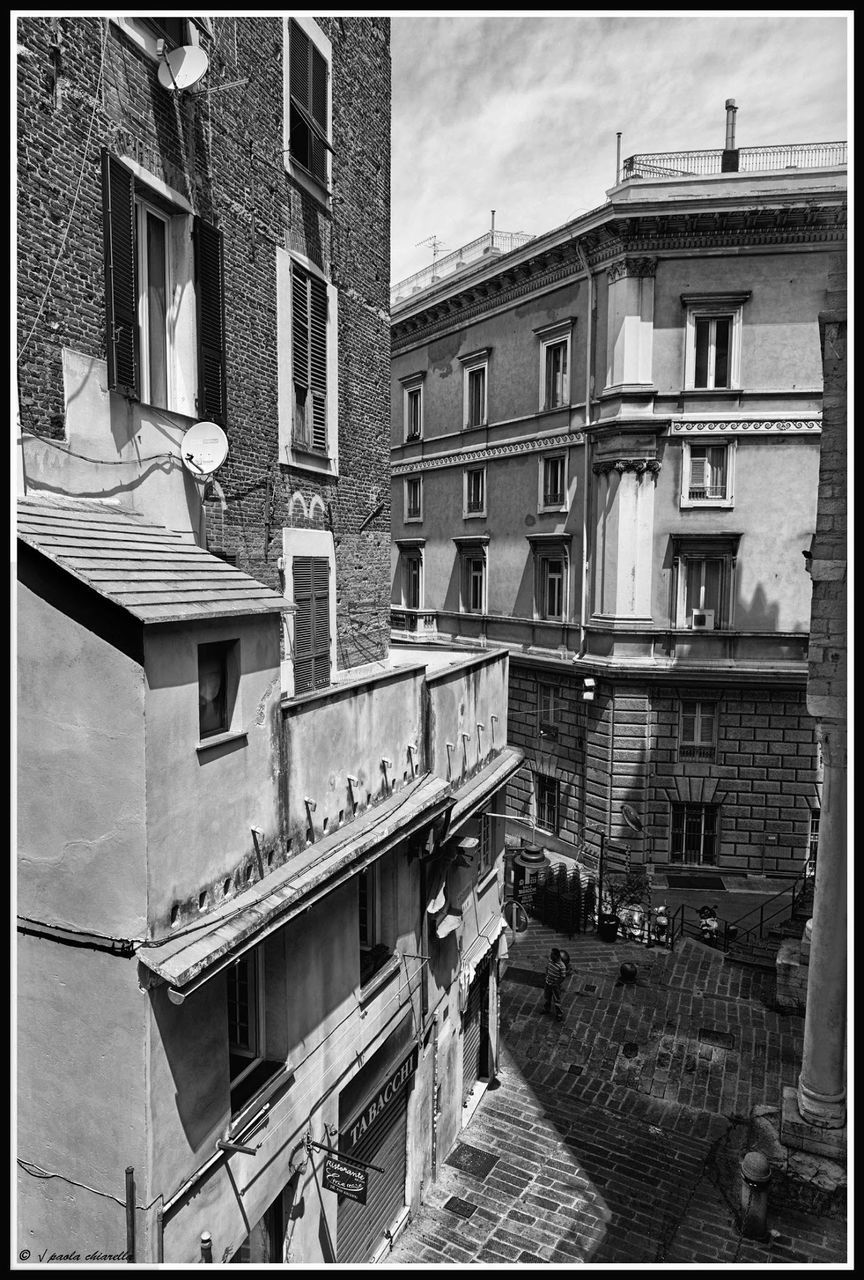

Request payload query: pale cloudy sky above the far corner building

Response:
[390,10,850,283]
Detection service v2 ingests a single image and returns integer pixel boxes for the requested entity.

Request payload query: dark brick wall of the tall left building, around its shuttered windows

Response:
[17,15,390,666]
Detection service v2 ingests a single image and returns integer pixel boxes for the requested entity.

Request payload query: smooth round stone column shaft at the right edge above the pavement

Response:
[797,721,846,1129]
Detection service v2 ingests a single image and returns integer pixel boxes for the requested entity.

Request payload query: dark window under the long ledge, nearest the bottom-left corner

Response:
[225,947,284,1114]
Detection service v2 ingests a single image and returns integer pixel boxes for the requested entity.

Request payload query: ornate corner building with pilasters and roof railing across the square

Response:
[392,127,846,877]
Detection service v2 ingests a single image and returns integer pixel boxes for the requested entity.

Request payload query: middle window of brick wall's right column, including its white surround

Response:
[276,247,339,475]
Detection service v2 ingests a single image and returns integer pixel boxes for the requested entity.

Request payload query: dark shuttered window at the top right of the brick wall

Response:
[285,18,333,196]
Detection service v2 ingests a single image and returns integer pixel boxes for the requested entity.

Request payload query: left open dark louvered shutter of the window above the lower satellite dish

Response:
[102,150,141,399]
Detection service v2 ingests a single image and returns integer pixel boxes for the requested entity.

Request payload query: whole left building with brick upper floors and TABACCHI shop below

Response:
[17,15,521,1265]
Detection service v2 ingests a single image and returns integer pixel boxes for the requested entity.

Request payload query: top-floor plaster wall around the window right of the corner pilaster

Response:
[653,252,828,396]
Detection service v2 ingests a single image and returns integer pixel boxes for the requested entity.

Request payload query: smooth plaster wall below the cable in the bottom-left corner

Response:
[17,936,152,1260]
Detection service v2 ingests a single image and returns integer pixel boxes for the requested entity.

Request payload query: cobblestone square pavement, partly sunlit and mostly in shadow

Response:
[385,922,846,1267]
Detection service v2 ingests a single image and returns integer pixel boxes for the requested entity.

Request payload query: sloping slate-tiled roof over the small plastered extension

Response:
[18,494,288,622]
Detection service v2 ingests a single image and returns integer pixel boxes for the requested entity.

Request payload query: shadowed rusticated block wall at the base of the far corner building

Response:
[508,657,818,876]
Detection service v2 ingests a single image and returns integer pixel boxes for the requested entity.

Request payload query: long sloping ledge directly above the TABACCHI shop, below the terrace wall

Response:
[137,774,453,998]
